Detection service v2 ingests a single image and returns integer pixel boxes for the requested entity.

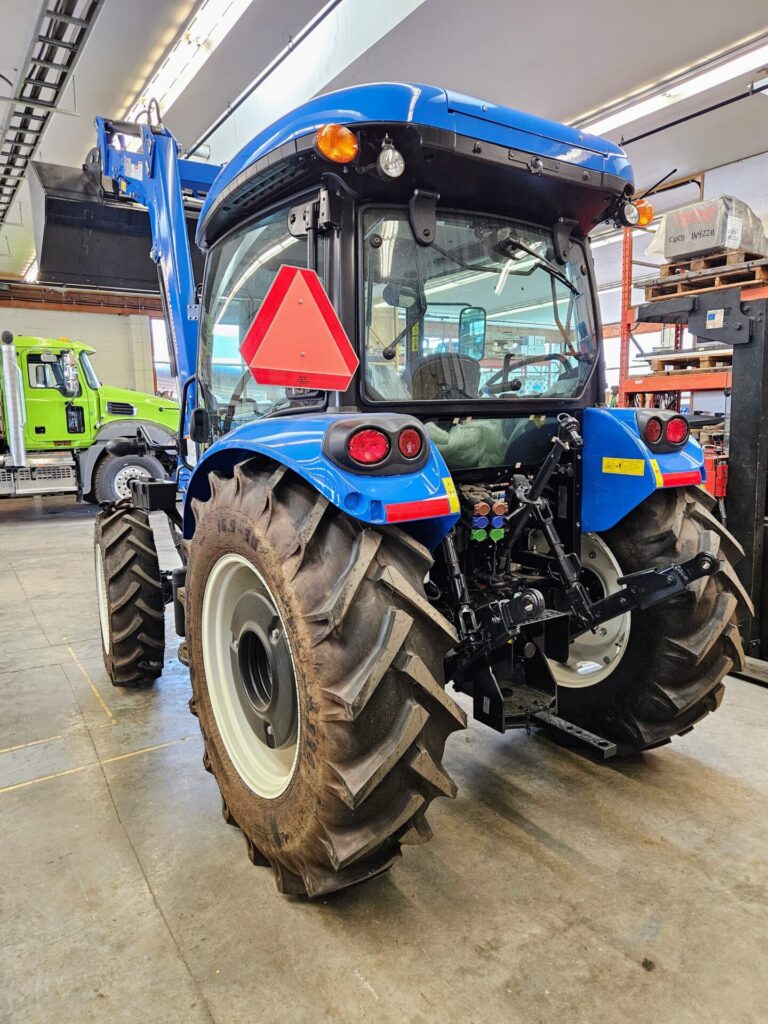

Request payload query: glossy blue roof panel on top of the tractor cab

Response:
[198,82,633,245]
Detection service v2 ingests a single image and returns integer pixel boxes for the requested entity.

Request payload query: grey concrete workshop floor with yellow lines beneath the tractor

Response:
[0,498,768,1024]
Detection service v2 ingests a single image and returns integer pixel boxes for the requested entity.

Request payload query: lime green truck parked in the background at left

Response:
[0,331,178,502]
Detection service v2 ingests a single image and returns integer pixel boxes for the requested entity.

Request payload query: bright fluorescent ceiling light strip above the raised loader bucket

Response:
[125,0,253,121]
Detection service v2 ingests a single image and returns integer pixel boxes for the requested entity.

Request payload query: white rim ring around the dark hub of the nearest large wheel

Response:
[201,554,301,800]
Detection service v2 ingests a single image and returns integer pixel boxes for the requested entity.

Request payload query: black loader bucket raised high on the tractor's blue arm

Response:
[29,161,204,293]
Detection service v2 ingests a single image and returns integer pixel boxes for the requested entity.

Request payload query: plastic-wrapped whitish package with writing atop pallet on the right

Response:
[646,196,768,260]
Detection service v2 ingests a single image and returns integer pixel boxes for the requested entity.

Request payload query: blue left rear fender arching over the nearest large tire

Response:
[183,414,459,548]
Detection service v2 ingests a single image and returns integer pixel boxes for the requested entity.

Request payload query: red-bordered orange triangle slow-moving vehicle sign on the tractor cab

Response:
[240,266,359,391]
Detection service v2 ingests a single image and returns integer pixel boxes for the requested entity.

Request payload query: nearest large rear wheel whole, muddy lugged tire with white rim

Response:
[186,462,466,896]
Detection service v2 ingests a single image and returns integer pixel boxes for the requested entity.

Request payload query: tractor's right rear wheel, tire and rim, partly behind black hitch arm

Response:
[550,487,752,753]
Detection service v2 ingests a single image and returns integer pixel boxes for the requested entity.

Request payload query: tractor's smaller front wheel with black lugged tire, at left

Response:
[93,506,165,687]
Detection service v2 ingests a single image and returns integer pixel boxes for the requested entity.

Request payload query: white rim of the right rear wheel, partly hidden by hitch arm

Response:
[536,534,632,689]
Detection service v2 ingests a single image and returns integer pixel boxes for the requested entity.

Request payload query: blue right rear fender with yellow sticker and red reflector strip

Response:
[582,409,706,532]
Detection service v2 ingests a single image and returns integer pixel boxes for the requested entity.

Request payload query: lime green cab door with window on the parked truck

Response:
[24,351,90,451]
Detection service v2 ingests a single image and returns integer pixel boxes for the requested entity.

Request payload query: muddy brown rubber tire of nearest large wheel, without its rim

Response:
[186,462,466,897]
